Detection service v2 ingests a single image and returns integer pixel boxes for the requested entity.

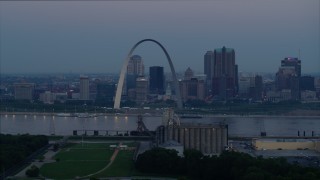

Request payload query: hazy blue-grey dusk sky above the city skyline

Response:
[0,0,320,73]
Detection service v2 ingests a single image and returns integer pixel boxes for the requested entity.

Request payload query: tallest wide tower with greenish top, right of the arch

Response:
[212,47,238,100]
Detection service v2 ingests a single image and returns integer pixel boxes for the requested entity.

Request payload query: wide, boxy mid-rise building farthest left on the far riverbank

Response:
[13,83,35,100]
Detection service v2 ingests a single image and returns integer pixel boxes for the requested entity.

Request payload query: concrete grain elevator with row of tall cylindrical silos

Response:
[156,110,228,154]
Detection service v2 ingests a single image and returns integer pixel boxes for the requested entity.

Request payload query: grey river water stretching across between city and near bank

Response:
[0,115,320,137]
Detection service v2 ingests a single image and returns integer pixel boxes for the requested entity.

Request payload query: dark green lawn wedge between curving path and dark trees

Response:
[94,150,135,178]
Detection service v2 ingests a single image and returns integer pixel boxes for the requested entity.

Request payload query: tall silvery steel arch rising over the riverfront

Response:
[113,39,182,109]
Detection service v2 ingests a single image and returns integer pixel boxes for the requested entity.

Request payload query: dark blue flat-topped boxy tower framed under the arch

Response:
[149,66,164,94]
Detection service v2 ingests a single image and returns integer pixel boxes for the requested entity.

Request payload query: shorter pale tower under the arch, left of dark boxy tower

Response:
[135,77,148,104]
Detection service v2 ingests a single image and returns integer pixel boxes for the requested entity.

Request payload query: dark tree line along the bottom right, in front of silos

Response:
[135,148,320,180]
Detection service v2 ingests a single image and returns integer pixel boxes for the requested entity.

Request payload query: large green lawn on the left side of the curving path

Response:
[40,143,116,179]
